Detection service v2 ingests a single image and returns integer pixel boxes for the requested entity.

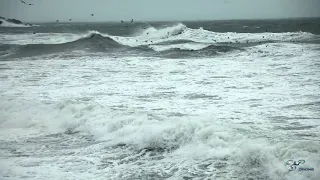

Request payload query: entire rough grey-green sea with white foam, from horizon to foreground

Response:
[0,18,320,180]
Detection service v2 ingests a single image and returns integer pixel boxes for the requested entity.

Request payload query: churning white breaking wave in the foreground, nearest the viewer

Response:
[0,100,320,180]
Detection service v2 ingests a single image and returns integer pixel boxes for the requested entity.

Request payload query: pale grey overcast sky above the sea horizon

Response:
[0,0,320,22]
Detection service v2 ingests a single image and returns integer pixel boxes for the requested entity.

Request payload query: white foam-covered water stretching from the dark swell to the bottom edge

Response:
[0,21,320,180]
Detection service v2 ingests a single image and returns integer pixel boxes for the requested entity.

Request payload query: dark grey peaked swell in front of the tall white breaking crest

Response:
[0,33,240,59]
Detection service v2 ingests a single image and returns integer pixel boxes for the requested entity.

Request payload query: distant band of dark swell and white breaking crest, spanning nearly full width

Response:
[0,23,320,58]
